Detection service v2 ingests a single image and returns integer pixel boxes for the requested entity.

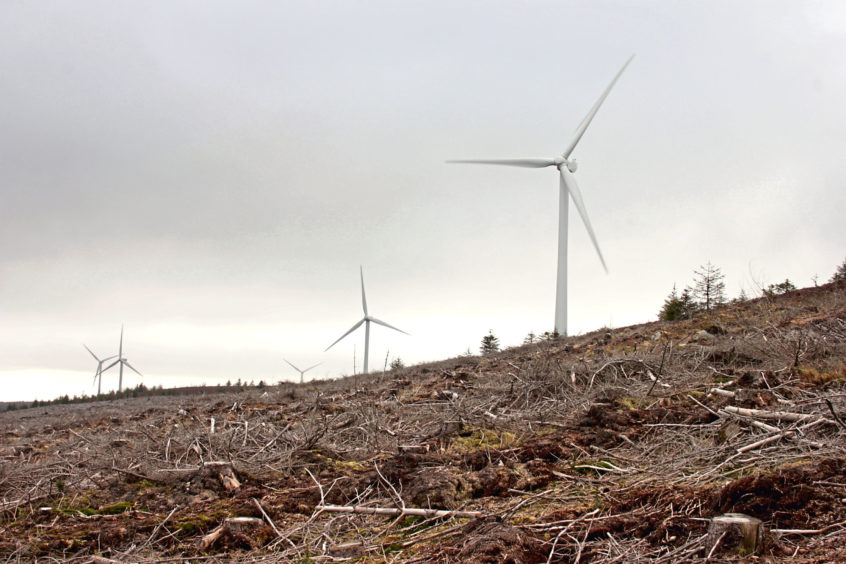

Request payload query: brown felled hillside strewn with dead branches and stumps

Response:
[0,284,846,563]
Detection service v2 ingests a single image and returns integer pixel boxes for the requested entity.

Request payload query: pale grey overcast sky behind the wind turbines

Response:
[0,0,846,400]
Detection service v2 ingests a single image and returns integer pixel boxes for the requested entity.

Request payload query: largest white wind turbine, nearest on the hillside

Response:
[447,55,634,336]
